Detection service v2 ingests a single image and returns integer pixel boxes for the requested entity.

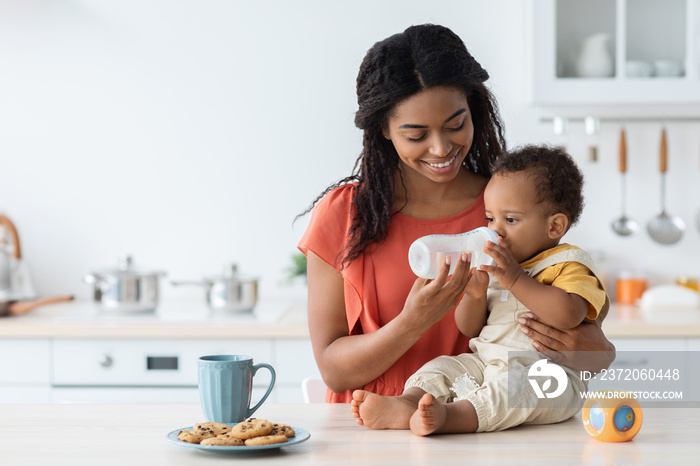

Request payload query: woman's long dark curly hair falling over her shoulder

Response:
[300,24,506,267]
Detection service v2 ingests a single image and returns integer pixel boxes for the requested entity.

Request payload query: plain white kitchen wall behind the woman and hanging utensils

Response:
[0,0,700,299]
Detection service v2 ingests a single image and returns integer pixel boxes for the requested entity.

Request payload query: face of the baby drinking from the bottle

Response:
[484,172,556,262]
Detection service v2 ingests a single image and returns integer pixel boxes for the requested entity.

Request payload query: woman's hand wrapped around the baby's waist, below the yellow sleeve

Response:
[518,312,615,374]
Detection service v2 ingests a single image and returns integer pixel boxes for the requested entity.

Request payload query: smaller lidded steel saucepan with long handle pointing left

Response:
[170,263,258,313]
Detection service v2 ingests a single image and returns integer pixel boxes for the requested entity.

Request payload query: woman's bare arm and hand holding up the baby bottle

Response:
[307,251,469,393]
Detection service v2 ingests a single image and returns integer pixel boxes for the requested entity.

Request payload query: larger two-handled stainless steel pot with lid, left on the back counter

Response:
[83,255,165,313]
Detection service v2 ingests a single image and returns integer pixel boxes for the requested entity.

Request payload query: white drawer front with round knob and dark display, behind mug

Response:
[51,339,274,387]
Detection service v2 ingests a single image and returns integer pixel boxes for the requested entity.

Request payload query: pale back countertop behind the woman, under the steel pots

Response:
[0,300,700,339]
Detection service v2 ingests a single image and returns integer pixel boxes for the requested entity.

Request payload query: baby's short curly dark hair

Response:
[493,145,584,228]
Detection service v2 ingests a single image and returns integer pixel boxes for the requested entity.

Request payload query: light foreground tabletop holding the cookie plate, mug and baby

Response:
[0,404,700,466]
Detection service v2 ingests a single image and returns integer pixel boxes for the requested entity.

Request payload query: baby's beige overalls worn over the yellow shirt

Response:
[404,249,610,432]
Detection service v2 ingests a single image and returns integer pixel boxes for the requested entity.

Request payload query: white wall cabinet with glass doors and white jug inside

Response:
[531,0,700,107]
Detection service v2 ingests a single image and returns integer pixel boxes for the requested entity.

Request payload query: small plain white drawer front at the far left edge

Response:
[0,339,50,385]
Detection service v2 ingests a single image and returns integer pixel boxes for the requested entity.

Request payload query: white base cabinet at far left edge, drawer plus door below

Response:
[0,339,50,403]
